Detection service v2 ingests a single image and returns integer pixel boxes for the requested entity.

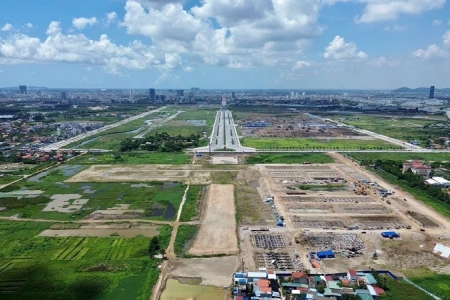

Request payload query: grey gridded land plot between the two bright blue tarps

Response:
[305,233,364,250]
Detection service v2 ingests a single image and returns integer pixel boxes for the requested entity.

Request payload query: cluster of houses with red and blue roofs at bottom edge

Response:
[233,268,386,300]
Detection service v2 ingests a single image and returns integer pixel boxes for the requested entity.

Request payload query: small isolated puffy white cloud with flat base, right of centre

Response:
[323,35,367,60]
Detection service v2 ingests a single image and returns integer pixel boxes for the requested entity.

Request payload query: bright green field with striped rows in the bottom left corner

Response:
[0,221,165,300]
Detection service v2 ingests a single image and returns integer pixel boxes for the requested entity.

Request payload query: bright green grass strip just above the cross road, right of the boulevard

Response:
[242,138,401,150]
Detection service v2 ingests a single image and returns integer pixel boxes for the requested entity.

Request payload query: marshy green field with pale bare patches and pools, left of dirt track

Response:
[0,165,185,220]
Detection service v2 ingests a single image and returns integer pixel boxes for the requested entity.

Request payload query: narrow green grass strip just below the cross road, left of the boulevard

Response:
[69,152,192,165]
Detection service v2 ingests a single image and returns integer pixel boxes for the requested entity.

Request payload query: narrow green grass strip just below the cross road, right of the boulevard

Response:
[246,153,333,164]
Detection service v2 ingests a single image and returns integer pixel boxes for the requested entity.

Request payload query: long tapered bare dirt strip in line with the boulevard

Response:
[188,184,238,255]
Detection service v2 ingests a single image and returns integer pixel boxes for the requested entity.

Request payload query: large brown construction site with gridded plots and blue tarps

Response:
[238,157,445,273]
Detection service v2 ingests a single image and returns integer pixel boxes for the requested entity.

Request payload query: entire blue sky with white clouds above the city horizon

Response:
[0,0,450,89]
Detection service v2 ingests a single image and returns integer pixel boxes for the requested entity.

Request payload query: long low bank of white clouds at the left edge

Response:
[0,22,164,73]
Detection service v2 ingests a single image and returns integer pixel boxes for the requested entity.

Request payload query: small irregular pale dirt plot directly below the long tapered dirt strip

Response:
[169,256,238,287]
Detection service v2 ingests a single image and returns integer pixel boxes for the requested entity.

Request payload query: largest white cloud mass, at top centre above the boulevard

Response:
[120,0,322,68]
